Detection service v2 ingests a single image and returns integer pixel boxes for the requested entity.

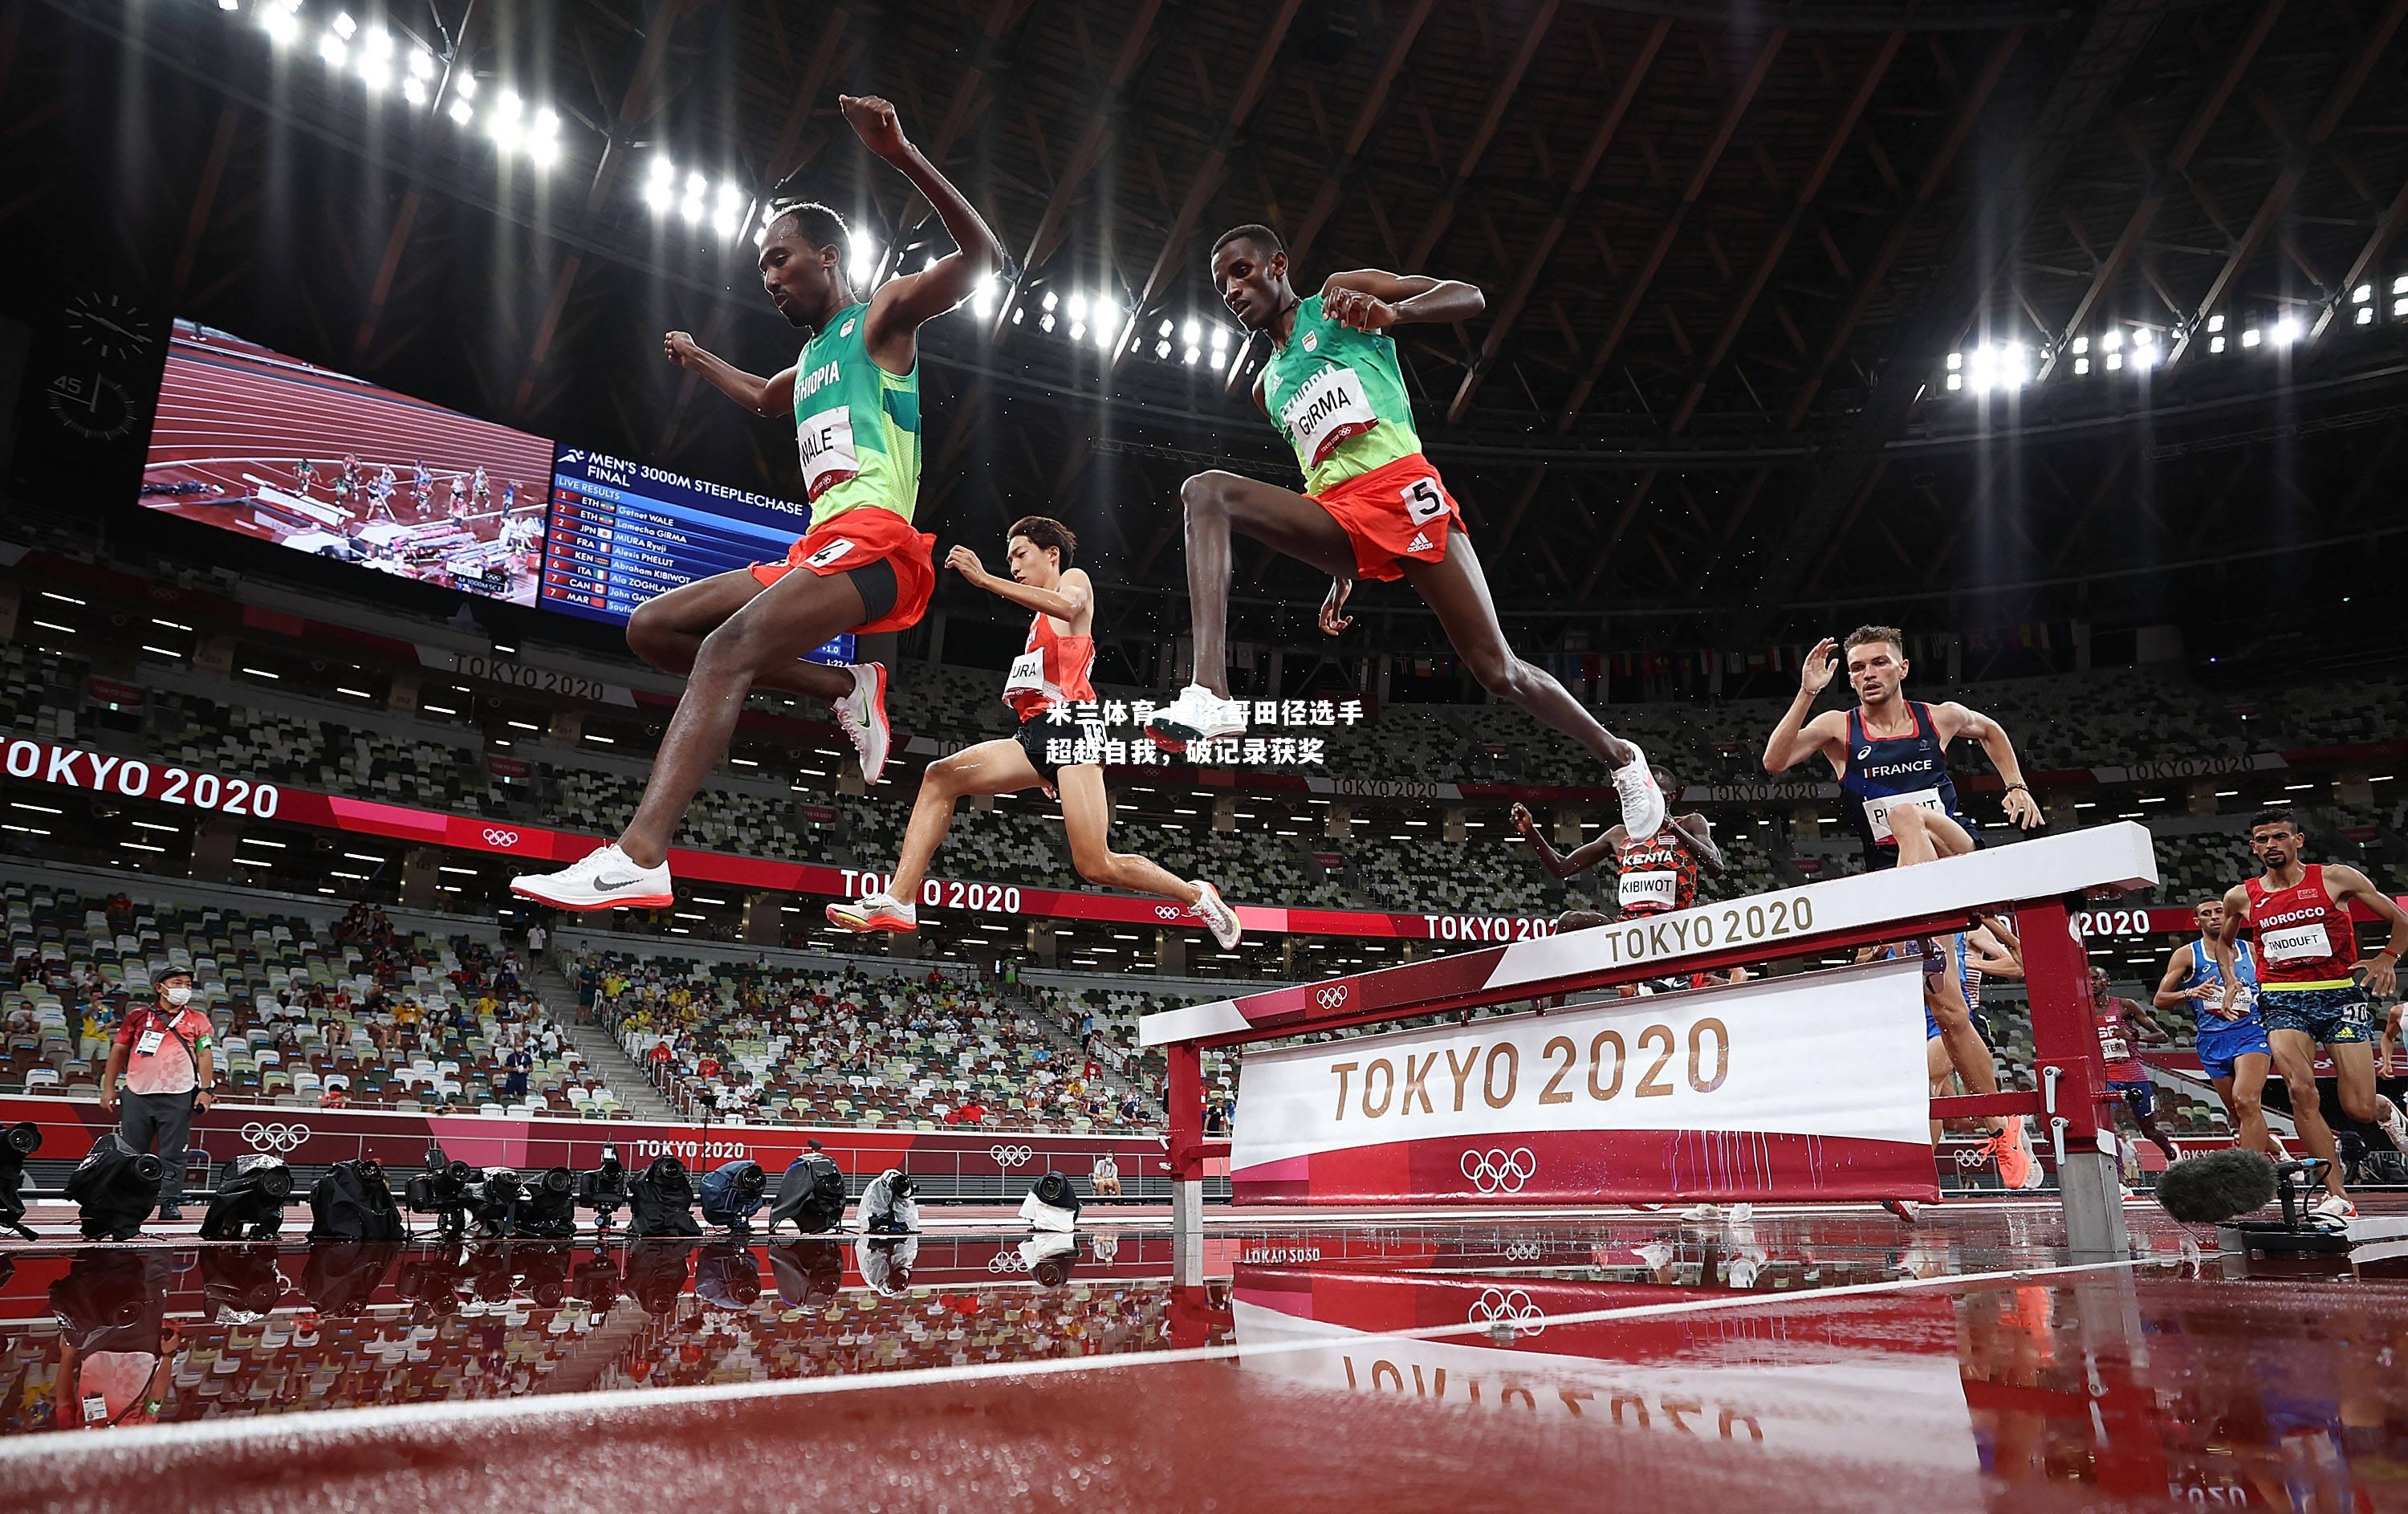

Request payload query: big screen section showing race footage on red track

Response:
[142,320,551,604]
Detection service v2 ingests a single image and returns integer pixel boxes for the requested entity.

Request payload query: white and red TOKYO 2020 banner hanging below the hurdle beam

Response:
[1230,960,1938,1206]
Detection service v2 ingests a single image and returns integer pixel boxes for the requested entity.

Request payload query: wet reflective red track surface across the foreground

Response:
[0,1203,2408,1514]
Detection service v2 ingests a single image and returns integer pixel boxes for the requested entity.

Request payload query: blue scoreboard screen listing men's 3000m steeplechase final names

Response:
[542,448,852,662]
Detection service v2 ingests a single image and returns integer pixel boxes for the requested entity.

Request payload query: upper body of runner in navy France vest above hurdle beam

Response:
[1765,626,2042,871]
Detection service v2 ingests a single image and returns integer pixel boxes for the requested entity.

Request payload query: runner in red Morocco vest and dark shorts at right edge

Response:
[2208,808,2408,1223]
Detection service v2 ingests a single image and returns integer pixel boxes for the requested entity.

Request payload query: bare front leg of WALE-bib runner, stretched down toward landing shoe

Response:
[619,563,864,869]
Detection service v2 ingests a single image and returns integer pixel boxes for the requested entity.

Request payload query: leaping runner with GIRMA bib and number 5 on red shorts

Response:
[1146,226,1664,840]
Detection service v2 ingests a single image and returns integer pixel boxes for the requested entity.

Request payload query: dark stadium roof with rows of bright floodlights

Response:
[0,0,2408,636]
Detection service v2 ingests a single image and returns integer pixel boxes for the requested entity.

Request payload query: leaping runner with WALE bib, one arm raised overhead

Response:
[510,96,1004,910]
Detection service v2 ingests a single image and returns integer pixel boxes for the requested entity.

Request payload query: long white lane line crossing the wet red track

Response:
[0,1256,2174,1463]
